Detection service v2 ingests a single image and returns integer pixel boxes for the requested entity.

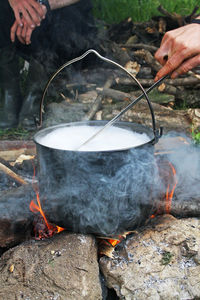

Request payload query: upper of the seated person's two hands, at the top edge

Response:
[8,0,46,28]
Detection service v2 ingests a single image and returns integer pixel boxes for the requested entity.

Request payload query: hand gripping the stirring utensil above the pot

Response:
[155,23,200,81]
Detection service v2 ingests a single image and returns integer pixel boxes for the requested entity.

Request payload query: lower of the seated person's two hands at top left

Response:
[10,18,34,45]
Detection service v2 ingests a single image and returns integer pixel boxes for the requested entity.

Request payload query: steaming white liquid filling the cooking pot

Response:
[38,126,150,151]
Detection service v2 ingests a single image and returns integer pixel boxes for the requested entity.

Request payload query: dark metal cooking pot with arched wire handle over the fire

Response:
[34,50,161,236]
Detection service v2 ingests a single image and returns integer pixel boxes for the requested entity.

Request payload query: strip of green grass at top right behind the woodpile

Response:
[92,0,200,24]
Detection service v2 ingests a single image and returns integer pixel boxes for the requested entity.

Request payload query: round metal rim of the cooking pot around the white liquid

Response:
[33,120,157,153]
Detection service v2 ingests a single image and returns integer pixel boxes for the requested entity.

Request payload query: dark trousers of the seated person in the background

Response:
[0,0,96,67]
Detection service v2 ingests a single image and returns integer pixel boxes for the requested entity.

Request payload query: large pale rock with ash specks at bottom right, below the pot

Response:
[100,215,200,300]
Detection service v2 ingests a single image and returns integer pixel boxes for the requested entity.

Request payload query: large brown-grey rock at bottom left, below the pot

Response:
[0,232,102,300]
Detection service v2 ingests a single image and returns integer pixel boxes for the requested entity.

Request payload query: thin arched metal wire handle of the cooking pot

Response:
[37,49,162,143]
